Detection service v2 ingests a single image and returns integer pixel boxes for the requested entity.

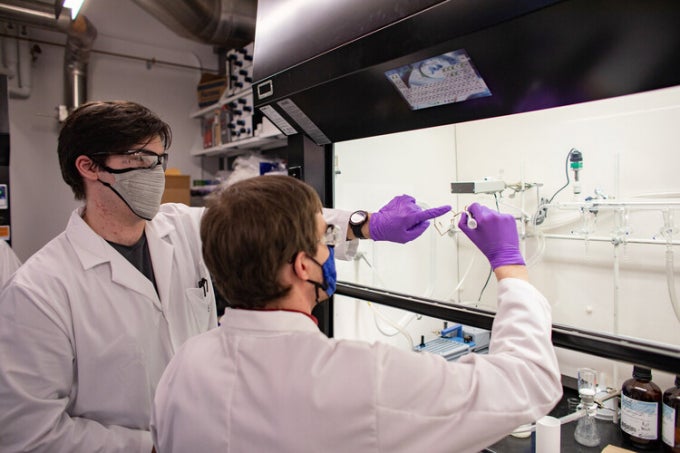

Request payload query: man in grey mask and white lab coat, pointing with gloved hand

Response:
[0,101,448,453]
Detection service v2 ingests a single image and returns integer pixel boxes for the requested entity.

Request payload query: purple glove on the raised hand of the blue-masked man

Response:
[458,203,524,269]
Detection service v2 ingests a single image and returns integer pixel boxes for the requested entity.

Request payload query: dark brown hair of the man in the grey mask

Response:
[57,101,172,200]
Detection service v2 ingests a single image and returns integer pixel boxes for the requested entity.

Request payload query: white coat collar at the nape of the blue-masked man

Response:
[220,308,319,333]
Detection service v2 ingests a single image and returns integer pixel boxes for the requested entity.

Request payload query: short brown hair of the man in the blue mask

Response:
[201,175,321,308]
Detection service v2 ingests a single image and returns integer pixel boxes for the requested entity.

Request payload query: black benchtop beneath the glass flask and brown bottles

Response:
[482,388,663,453]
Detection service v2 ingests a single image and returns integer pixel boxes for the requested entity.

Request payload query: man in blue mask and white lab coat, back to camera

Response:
[151,176,562,453]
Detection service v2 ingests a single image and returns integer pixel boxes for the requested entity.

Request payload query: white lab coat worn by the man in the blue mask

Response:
[151,279,562,453]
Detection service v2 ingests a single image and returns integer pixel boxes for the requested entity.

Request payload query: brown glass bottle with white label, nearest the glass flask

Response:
[620,366,661,450]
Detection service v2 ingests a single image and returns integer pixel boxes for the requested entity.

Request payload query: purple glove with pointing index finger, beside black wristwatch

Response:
[368,195,451,244]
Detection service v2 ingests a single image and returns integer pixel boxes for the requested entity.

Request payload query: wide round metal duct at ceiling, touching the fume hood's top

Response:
[134,0,257,49]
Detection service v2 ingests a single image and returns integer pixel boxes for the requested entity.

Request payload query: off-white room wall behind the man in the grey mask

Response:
[4,0,217,260]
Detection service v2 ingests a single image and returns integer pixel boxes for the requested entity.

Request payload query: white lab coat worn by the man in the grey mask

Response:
[0,204,350,453]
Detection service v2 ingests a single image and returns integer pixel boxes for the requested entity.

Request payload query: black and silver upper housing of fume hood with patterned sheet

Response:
[253,0,680,144]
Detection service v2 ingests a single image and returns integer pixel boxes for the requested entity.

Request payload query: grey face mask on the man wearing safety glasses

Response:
[99,165,165,220]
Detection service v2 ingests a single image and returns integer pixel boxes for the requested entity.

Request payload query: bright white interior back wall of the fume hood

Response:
[335,87,680,387]
